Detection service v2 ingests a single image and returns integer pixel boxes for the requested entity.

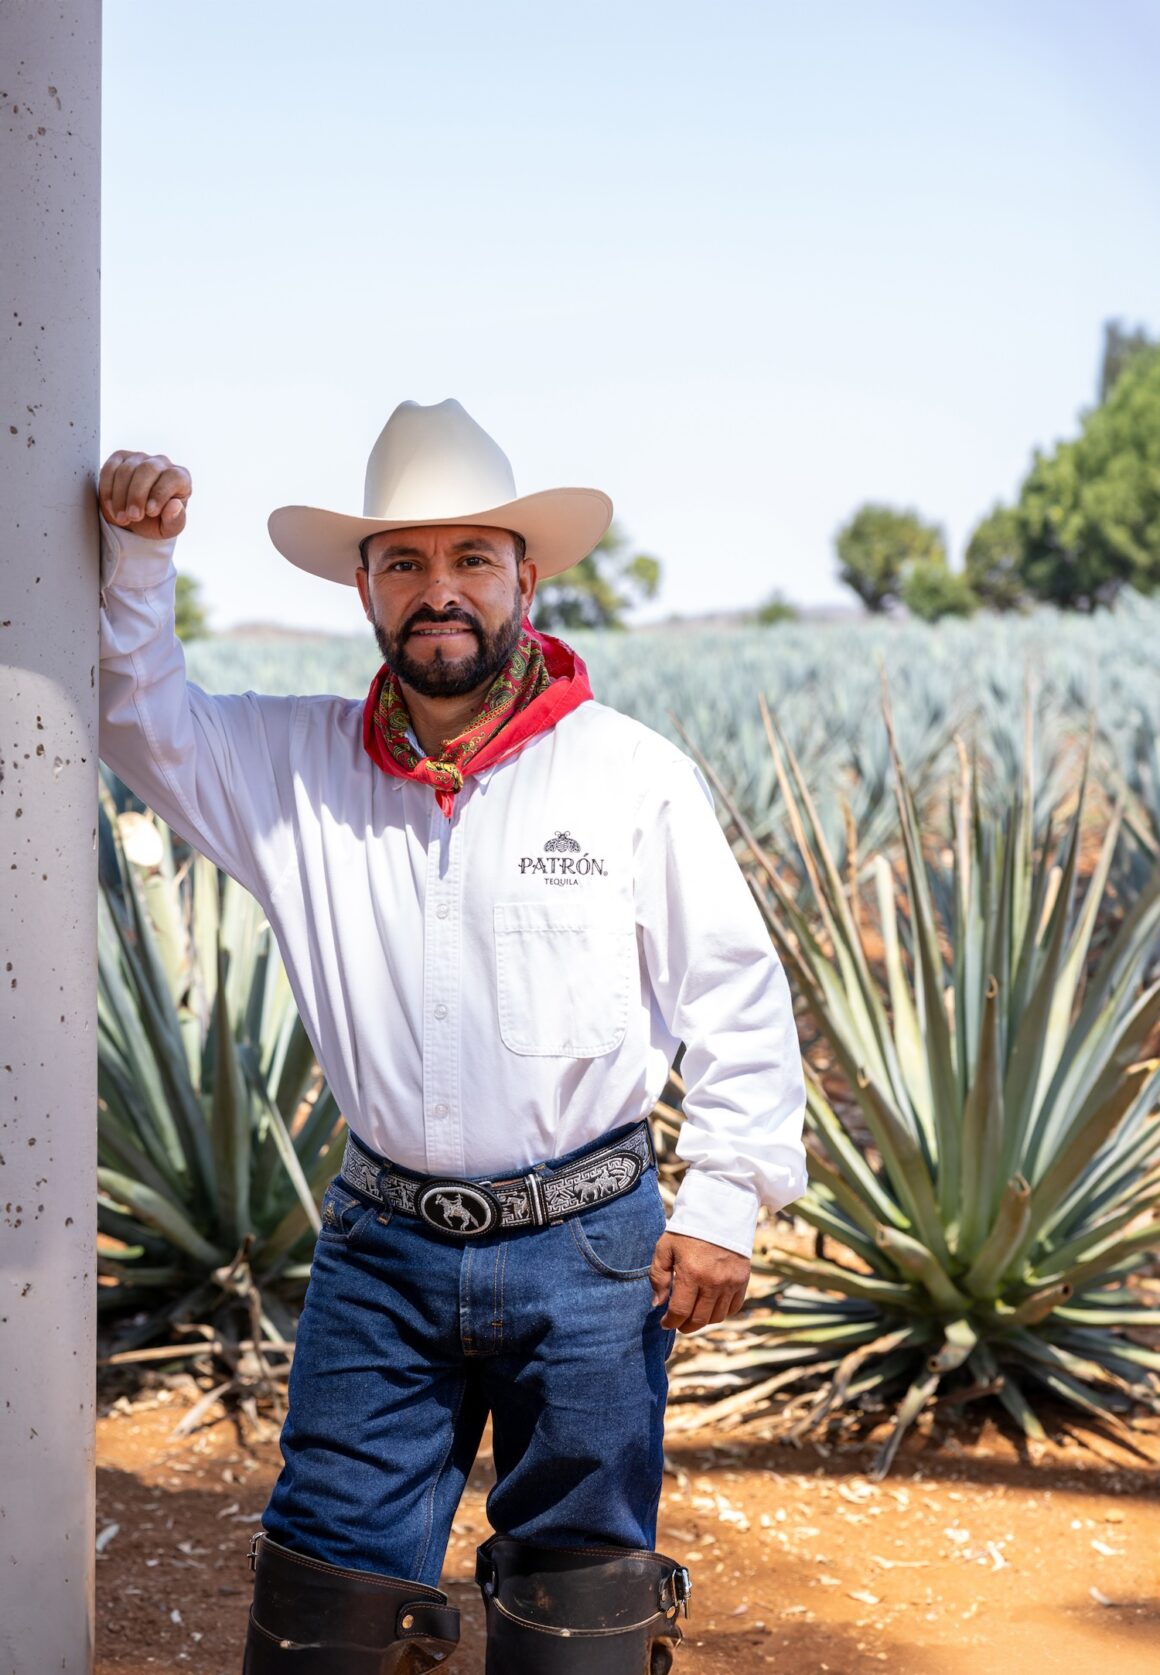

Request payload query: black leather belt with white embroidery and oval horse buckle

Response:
[340,1122,656,1240]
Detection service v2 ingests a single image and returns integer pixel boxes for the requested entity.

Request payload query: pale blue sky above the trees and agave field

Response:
[102,0,1160,631]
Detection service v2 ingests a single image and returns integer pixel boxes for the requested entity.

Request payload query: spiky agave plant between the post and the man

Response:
[97,794,341,1343]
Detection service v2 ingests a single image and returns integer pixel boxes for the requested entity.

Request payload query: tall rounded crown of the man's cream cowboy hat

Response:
[363,400,516,523]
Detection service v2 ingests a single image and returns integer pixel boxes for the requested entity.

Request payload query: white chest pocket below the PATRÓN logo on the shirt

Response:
[495,901,636,1059]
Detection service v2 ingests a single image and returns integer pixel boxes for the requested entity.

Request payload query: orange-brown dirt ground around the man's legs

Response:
[97,1390,1160,1675]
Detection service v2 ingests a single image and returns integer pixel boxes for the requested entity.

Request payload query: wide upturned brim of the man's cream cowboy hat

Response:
[268,489,613,588]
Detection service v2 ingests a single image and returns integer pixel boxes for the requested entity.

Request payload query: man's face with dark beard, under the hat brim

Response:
[355,524,536,698]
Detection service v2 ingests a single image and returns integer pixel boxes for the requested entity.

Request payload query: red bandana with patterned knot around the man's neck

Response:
[363,621,593,819]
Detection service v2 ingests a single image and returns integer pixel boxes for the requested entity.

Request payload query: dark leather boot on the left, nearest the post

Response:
[243,1534,459,1675]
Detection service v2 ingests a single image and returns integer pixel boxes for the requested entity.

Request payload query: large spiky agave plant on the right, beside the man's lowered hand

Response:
[676,710,1160,1474]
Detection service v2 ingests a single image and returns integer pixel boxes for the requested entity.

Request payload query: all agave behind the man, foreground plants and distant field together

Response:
[100,600,1160,1471]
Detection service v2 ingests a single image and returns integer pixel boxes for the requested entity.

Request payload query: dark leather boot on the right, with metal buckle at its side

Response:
[475,1536,690,1675]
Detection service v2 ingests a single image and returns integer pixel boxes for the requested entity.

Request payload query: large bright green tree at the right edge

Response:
[1016,347,1160,611]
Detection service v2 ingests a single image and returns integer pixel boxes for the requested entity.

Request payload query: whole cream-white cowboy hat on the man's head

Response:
[268,400,613,588]
